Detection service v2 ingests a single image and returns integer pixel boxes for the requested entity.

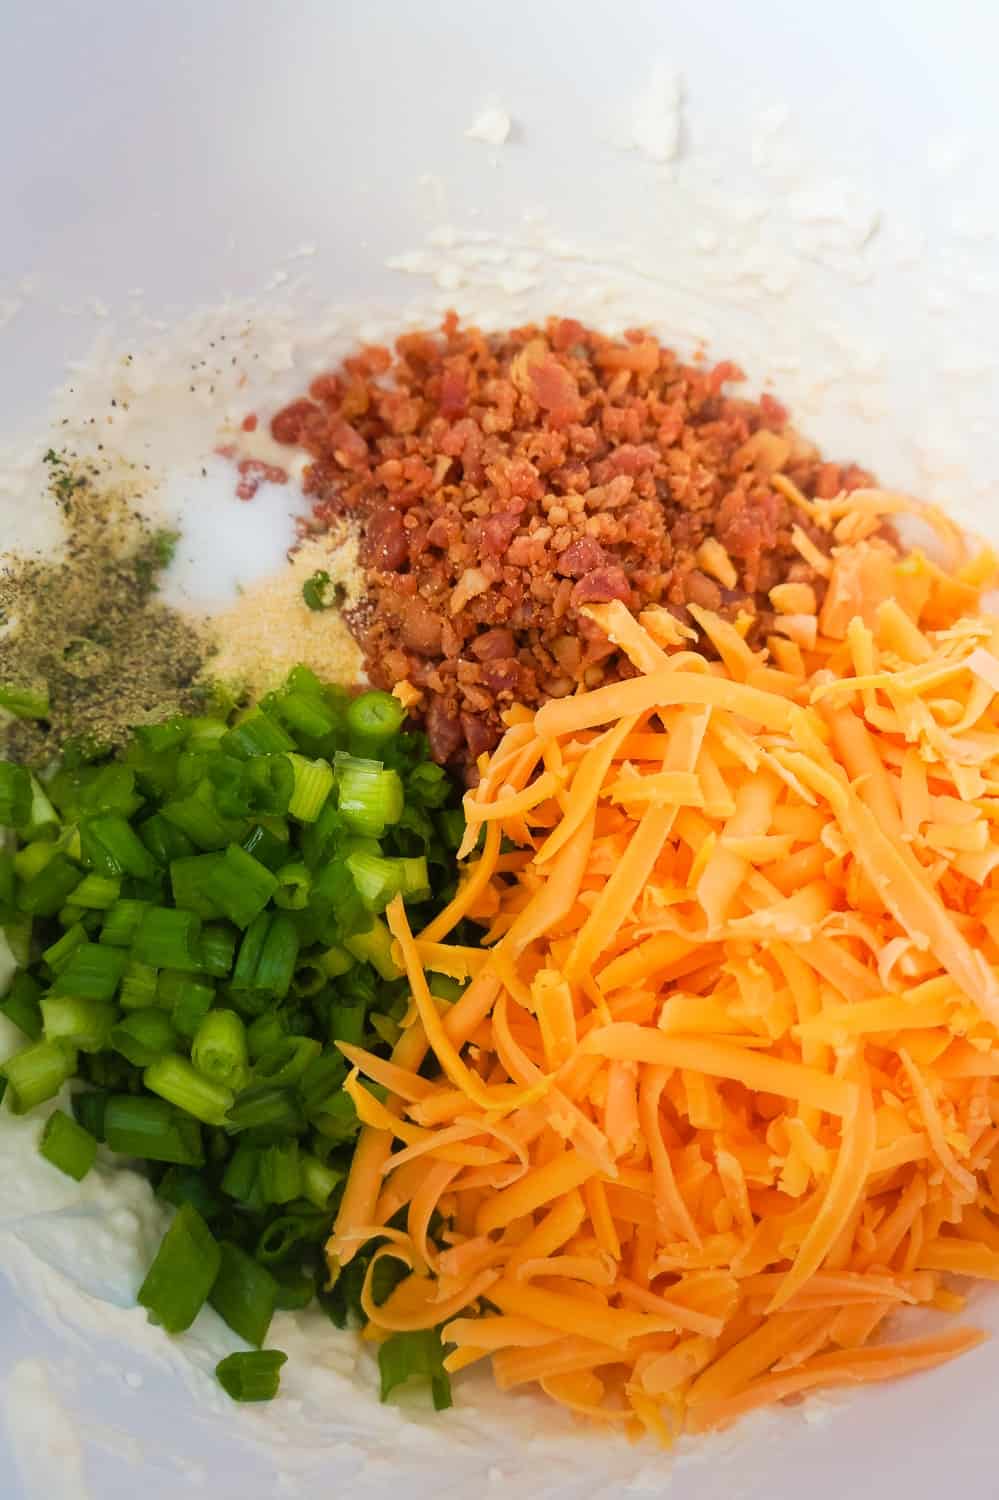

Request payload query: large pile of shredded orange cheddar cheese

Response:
[329,492,999,1443]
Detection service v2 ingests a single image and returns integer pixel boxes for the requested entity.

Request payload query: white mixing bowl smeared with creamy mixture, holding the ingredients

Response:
[0,0,999,1500]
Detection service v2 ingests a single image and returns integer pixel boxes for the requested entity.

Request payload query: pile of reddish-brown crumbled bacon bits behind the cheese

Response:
[272,314,870,765]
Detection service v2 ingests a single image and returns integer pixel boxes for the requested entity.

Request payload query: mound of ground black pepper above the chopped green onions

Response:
[0,452,206,762]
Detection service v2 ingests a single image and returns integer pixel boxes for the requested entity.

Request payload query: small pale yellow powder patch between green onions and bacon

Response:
[207,525,365,696]
